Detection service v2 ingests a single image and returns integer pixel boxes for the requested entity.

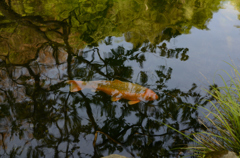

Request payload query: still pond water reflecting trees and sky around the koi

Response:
[0,0,240,158]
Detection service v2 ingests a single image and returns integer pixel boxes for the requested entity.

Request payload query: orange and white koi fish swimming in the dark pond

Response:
[66,80,158,105]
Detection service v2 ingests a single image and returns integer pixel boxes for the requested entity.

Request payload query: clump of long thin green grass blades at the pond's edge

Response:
[167,63,240,157]
